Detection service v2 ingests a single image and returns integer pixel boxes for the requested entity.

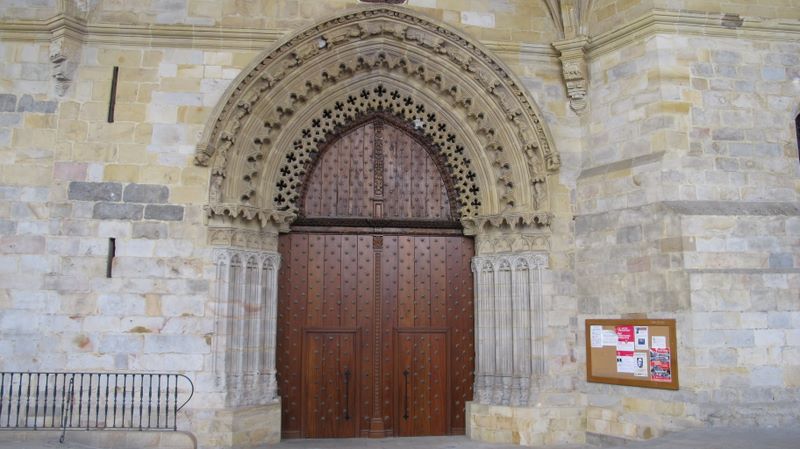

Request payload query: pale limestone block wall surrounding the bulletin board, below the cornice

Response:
[575,22,800,438]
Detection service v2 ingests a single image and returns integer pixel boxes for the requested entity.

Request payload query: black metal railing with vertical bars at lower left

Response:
[0,372,194,442]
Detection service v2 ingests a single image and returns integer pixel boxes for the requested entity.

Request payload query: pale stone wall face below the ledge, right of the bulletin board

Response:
[682,211,800,426]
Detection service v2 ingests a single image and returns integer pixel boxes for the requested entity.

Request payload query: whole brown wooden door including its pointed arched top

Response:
[277,111,475,438]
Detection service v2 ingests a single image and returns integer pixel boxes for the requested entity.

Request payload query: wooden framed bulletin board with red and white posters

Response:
[586,319,678,390]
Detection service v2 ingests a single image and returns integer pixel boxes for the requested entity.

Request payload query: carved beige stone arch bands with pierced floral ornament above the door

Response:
[195,6,560,230]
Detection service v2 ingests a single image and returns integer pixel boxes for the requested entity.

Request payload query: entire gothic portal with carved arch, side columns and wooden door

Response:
[203,5,560,444]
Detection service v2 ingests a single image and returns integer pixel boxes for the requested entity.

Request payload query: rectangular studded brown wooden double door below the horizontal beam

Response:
[277,232,474,438]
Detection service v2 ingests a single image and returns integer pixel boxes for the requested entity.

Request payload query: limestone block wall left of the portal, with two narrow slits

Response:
[0,37,255,447]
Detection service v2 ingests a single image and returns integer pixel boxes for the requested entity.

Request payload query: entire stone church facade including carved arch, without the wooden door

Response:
[0,0,800,448]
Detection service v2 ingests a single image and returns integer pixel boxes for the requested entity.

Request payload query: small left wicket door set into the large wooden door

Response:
[303,331,358,438]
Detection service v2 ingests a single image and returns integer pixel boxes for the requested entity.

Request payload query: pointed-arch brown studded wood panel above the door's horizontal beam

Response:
[296,111,460,227]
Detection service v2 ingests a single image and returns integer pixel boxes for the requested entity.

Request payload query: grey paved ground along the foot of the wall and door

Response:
[0,427,800,449]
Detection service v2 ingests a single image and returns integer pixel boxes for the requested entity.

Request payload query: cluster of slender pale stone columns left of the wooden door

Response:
[213,248,281,406]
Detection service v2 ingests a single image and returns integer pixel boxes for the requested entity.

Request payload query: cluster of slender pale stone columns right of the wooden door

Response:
[472,252,547,406]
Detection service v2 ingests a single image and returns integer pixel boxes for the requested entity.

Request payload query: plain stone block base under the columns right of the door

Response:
[467,402,586,446]
